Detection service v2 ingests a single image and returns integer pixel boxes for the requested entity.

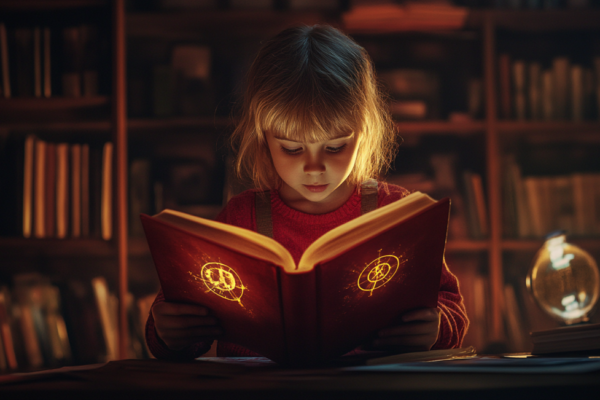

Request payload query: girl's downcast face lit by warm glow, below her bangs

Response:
[266,132,358,214]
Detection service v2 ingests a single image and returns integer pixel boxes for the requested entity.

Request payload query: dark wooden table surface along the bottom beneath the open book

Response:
[0,360,600,400]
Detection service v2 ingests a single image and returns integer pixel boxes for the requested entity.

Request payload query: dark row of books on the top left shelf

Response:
[0,22,100,98]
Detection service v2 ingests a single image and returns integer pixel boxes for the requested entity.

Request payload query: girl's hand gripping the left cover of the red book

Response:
[152,302,223,351]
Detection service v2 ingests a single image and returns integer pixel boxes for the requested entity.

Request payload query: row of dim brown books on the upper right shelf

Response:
[499,54,600,121]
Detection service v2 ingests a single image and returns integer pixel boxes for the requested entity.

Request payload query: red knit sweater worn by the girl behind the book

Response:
[146,182,469,360]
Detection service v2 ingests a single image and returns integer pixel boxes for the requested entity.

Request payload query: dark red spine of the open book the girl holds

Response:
[280,269,321,365]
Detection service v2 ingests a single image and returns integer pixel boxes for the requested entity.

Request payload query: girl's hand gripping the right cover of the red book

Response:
[369,308,440,353]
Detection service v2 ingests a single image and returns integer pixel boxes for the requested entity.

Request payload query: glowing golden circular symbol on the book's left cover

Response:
[195,262,246,305]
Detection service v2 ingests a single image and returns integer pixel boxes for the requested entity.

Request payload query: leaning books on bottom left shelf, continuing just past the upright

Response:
[0,274,154,372]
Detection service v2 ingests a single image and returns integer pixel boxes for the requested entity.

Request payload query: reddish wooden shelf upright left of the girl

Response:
[112,0,129,359]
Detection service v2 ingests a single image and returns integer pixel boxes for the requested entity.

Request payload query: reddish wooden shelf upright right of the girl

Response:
[482,11,505,343]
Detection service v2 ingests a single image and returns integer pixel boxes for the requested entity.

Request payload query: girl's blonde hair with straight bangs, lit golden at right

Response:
[231,25,397,189]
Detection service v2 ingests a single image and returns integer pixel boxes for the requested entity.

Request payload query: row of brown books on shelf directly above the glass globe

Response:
[503,155,600,238]
